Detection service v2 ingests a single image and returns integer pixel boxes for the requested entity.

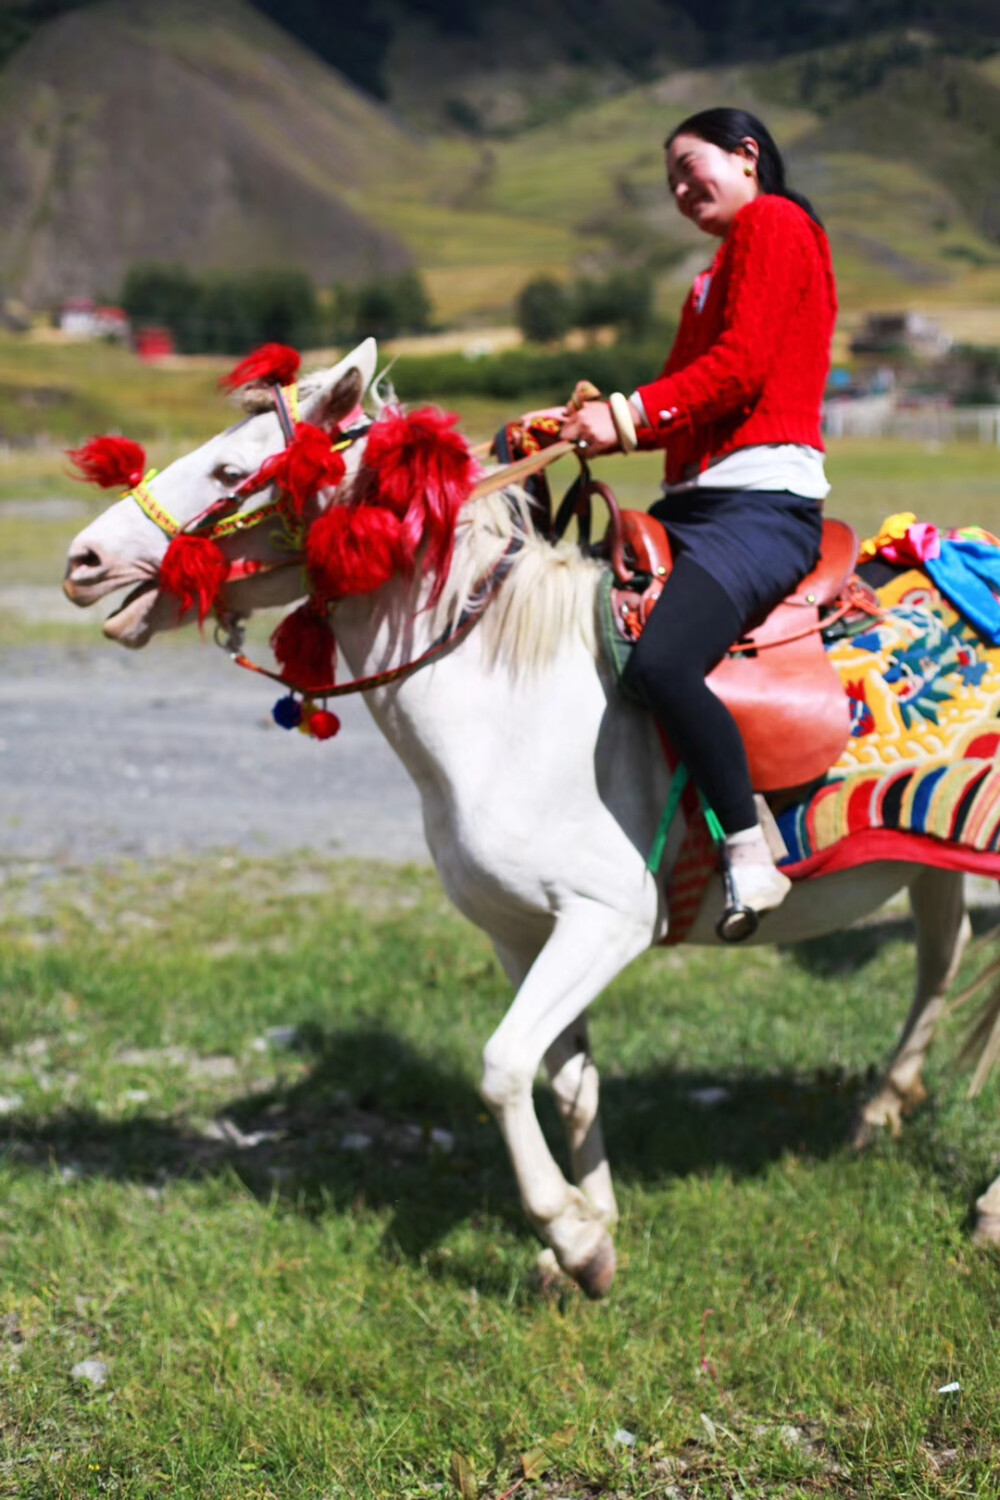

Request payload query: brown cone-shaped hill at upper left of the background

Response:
[0,0,421,305]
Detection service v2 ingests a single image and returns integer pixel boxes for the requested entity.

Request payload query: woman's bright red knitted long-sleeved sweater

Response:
[639,194,837,485]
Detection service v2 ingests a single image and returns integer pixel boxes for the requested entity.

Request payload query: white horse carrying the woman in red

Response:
[64,341,1000,1296]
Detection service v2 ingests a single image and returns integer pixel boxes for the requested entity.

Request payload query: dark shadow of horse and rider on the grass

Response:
[0,1026,893,1289]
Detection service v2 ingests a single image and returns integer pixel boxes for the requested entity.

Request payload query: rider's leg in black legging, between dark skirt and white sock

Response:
[625,554,757,834]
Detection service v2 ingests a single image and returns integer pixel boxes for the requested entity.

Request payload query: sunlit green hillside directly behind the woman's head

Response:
[357,35,1000,325]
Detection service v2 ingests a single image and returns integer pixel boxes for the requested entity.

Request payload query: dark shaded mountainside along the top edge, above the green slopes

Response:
[256,0,1000,135]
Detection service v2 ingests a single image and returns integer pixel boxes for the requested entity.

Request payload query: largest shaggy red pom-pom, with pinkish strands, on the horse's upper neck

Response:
[364,407,477,594]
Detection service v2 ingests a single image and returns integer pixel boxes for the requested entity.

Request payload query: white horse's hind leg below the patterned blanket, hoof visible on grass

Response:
[855,869,972,1146]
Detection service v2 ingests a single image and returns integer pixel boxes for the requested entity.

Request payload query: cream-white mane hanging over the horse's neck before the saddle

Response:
[432,485,601,674]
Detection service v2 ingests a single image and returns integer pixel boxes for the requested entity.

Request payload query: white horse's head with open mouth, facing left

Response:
[63,339,376,650]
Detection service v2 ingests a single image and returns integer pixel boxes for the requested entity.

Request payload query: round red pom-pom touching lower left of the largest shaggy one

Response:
[306,506,405,599]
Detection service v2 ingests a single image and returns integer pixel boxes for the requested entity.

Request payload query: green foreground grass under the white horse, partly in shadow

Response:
[0,857,1000,1500]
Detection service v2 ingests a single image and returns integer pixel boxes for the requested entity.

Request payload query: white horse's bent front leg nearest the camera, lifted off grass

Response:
[481,900,649,1298]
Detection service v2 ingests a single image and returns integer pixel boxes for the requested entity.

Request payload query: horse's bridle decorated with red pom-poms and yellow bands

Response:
[69,345,497,740]
